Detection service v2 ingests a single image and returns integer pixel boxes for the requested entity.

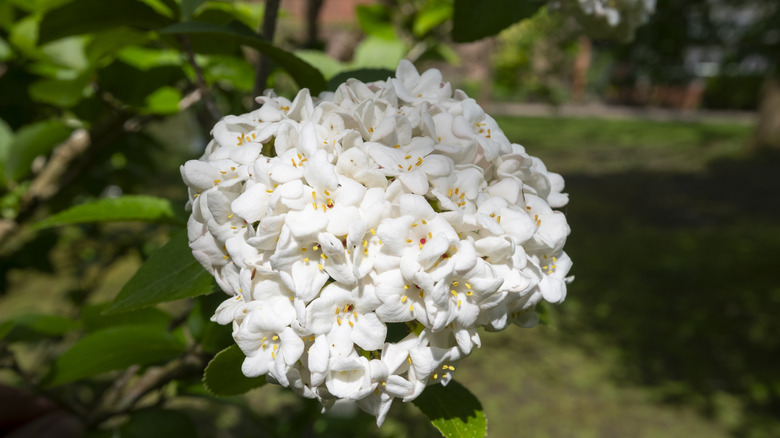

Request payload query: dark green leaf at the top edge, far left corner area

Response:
[38,0,172,44]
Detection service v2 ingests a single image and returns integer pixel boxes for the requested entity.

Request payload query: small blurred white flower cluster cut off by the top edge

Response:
[569,0,656,41]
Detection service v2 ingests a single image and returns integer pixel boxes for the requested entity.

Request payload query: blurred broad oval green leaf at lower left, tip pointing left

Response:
[42,325,186,387]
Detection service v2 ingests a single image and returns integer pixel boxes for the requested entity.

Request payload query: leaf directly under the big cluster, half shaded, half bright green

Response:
[414,380,487,438]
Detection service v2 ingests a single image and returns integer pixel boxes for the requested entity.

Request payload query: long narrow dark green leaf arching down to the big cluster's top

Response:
[160,21,327,95]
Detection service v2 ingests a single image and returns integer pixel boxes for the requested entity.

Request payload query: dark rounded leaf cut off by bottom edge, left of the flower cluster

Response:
[119,408,198,438]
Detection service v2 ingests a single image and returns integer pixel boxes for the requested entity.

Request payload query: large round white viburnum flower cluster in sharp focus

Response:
[181,61,571,424]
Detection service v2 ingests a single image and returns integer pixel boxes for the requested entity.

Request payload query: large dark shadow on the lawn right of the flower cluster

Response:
[559,150,780,436]
